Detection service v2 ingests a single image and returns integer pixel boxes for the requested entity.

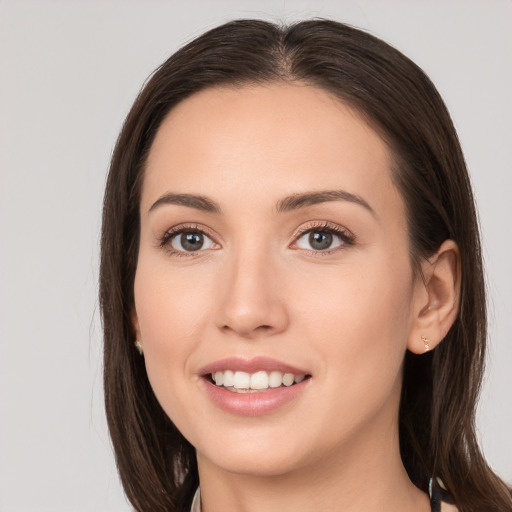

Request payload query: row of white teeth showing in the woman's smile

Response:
[212,370,306,392]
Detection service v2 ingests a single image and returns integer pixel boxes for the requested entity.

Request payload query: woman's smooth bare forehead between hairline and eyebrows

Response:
[142,84,398,218]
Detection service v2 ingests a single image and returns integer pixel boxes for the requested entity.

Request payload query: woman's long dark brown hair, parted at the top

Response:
[100,20,512,512]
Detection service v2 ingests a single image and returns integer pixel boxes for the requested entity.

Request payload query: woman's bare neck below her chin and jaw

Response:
[198,410,430,512]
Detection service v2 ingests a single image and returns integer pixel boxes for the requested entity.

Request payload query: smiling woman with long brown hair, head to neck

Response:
[100,20,512,512]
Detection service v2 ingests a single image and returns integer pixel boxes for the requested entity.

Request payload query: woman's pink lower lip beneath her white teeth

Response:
[202,378,311,416]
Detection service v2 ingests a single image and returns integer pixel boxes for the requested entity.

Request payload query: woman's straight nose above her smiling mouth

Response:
[217,253,288,339]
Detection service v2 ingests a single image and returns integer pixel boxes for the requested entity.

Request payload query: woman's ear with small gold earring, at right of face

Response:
[407,240,461,354]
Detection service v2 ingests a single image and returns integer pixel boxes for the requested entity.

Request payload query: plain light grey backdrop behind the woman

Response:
[0,0,512,512]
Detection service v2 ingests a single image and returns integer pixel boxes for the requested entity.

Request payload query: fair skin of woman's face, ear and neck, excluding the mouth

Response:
[133,84,460,512]
